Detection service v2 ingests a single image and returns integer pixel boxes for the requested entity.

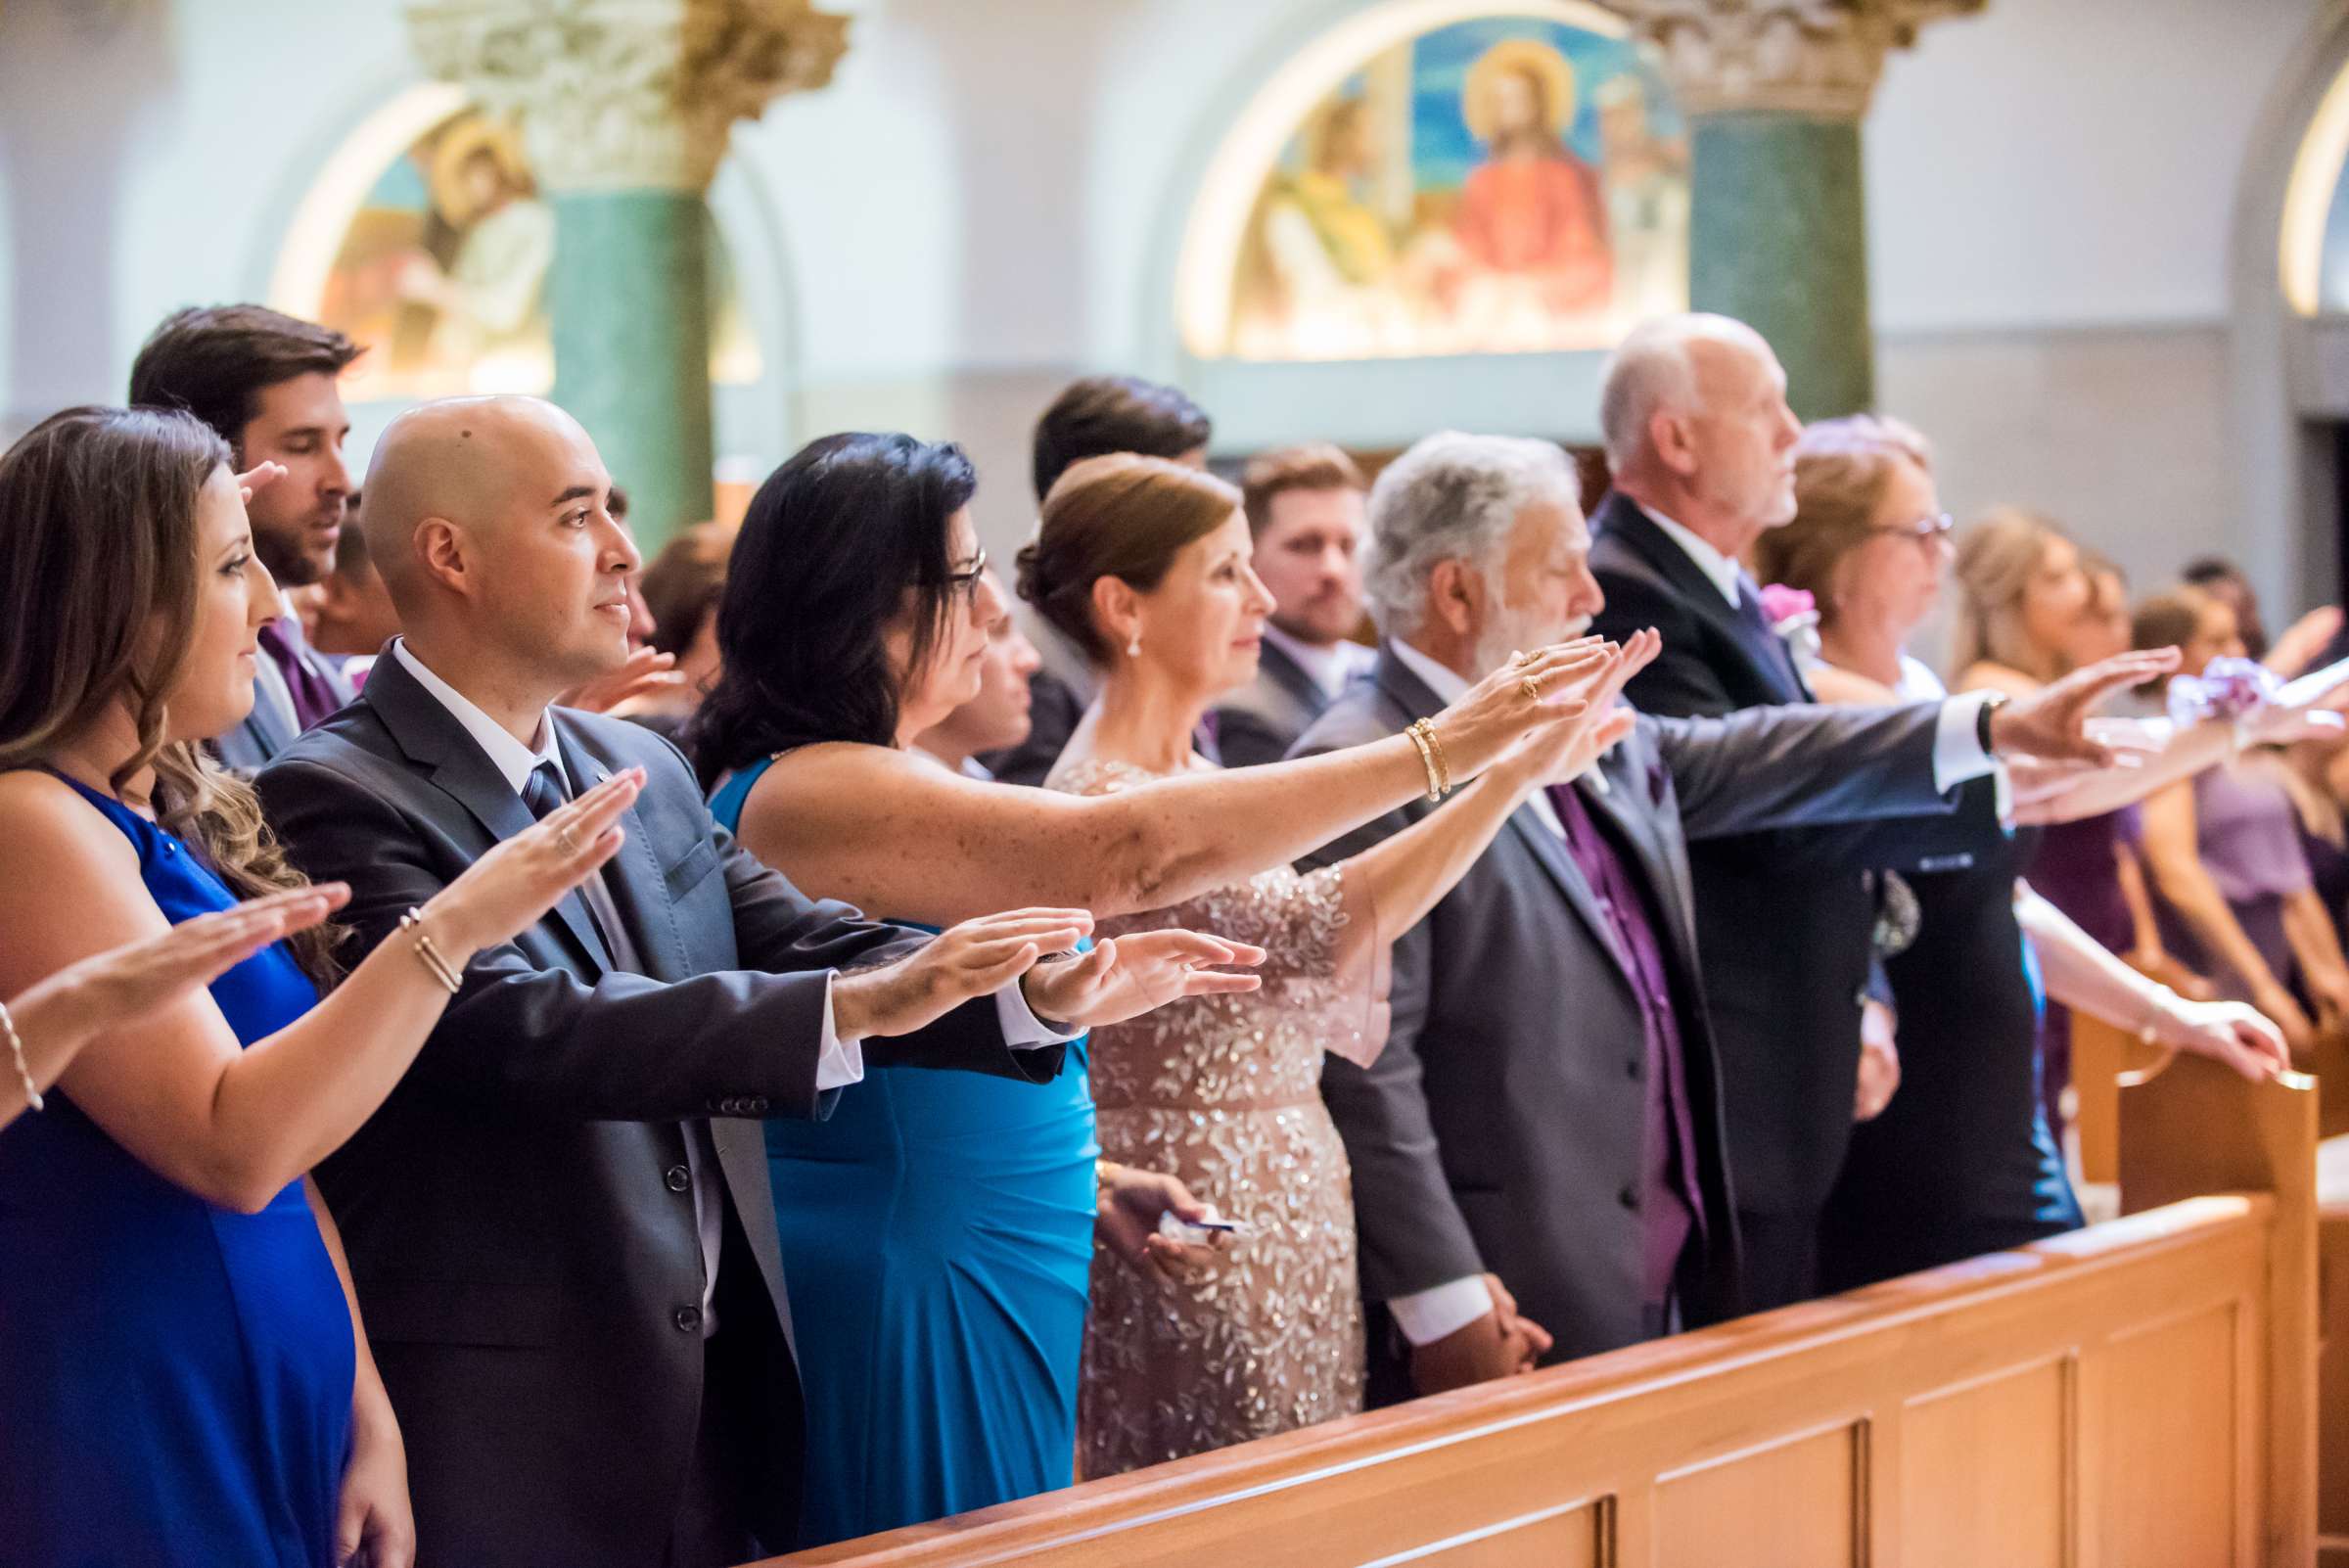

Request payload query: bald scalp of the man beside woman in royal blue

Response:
[359,396,611,618]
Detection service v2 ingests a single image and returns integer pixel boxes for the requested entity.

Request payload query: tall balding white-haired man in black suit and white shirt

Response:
[1590,314,1935,1308]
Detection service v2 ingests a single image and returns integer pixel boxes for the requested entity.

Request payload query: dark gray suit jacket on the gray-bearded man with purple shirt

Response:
[1294,653,1973,1361]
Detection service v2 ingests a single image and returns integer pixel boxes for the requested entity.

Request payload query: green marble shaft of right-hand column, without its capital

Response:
[1689,111,1877,420]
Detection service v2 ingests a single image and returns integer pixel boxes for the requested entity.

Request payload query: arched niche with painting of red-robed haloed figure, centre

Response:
[1132,0,1686,448]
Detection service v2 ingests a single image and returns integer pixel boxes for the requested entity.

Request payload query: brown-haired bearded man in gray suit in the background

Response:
[1215,441,1372,767]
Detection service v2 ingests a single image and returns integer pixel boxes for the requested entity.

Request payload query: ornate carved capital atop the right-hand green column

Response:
[1607,0,1987,119]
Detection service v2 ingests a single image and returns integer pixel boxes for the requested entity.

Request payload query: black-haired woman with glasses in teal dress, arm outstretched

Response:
[693,435,1611,1545]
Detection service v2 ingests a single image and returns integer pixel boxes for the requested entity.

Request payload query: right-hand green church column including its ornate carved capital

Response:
[1607,0,1985,420]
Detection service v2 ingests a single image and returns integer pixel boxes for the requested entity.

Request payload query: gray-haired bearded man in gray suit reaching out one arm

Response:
[1297,435,2163,1399]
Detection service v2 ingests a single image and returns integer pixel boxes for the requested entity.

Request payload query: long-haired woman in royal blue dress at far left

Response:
[0,408,636,1568]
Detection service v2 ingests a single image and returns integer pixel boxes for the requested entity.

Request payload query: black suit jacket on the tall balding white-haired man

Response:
[1590,493,1999,1214]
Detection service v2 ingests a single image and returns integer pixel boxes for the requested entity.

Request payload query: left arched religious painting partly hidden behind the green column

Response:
[317,108,761,401]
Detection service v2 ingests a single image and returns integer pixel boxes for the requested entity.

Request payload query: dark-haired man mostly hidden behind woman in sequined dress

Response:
[980,376,1215,784]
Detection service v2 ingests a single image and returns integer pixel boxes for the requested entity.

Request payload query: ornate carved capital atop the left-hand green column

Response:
[406,0,848,195]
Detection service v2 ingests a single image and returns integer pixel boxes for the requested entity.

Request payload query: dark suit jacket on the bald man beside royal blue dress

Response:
[258,657,1059,1568]
